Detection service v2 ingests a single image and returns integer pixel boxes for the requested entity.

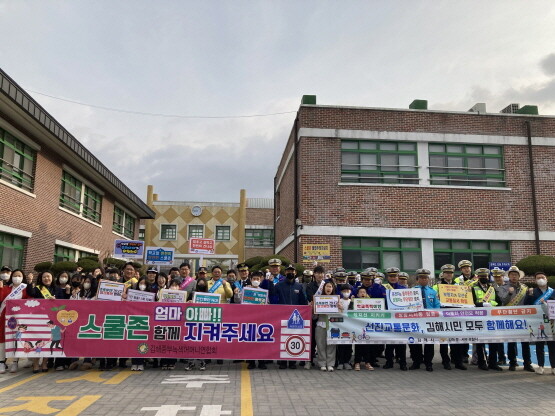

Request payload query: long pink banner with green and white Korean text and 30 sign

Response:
[5,299,311,361]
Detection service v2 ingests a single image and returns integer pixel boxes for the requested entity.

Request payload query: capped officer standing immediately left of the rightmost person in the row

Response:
[501,266,535,373]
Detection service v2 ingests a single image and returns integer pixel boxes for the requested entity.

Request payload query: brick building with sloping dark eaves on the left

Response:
[0,70,154,272]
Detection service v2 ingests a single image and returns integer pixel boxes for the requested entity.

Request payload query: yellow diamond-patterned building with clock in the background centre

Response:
[141,185,274,269]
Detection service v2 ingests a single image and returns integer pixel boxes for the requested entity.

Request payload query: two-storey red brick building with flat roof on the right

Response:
[274,96,555,272]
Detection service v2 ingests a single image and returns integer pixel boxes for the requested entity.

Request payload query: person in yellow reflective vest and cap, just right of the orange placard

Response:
[472,267,503,371]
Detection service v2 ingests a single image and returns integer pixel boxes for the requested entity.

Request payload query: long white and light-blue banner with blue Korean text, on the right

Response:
[328,305,553,344]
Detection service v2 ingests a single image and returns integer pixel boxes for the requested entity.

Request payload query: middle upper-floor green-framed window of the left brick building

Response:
[60,171,102,224]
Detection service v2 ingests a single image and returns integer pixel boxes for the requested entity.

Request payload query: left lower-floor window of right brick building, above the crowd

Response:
[343,237,422,273]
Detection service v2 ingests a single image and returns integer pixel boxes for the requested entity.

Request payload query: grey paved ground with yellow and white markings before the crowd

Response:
[0,354,555,416]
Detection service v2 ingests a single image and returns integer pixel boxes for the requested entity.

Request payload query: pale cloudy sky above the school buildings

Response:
[0,0,555,202]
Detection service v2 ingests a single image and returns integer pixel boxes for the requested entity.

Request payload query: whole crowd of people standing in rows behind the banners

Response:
[0,259,555,375]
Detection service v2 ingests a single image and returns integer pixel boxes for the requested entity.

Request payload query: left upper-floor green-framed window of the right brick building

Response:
[341,140,419,184]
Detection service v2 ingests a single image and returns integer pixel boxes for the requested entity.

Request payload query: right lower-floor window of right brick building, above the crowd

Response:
[434,240,511,273]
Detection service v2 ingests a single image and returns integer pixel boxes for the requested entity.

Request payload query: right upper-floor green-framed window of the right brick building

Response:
[428,143,505,187]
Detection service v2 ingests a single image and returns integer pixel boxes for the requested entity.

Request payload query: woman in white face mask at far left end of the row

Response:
[0,266,27,374]
